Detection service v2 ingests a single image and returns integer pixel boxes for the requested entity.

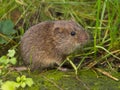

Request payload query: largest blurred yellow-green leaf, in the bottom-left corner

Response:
[1,81,17,90]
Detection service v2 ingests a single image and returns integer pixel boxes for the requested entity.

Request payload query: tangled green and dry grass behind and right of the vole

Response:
[0,0,120,76]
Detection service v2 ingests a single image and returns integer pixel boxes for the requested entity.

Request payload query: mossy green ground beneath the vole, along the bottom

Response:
[4,69,120,90]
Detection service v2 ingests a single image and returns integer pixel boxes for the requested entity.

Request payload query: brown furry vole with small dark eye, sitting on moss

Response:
[20,20,89,70]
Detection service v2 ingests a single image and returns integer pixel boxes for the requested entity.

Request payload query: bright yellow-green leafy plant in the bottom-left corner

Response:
[1,75,34,90]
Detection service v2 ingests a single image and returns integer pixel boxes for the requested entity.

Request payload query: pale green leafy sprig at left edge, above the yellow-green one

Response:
[0,49,17,76]
